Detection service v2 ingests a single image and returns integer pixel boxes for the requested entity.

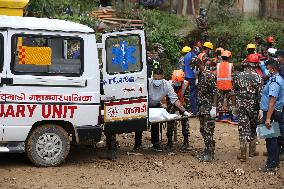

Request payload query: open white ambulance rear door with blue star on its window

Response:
[102,30,148,133]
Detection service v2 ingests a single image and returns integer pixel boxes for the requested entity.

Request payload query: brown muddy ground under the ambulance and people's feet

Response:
[0,119,284,189]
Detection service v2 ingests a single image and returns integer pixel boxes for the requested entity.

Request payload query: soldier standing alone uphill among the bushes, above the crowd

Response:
[196,7,208,41]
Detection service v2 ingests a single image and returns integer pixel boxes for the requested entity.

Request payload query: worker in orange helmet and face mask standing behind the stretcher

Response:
[166,70,190,151]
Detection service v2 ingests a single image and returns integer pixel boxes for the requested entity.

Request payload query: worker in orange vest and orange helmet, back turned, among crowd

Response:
[216,50,233,122]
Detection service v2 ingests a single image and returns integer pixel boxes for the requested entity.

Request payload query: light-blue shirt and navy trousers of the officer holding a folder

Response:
[260,73,284,168]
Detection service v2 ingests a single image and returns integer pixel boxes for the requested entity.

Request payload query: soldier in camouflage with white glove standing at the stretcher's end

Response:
[198,52,217,162]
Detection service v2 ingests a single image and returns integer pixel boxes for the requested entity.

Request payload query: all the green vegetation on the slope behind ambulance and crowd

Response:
[26,0,284,74]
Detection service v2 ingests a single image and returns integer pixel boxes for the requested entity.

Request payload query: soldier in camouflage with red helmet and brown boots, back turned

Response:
[232,54,263,162]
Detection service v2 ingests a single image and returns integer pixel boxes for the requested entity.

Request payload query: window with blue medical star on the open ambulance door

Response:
[105,35,143,74]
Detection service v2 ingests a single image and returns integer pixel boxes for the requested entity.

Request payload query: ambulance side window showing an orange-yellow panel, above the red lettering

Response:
[11,35,83,76]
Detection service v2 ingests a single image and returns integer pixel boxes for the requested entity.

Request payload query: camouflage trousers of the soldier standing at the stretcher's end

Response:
[199,114,215,151]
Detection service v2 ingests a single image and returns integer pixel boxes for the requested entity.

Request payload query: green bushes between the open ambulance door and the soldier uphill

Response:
[116,9,195,78]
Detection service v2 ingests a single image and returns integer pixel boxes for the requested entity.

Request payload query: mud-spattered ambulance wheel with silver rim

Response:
[26,124,70,167]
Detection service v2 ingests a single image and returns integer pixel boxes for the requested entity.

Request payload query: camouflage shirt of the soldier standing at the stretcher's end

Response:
[198,70,217,115]
